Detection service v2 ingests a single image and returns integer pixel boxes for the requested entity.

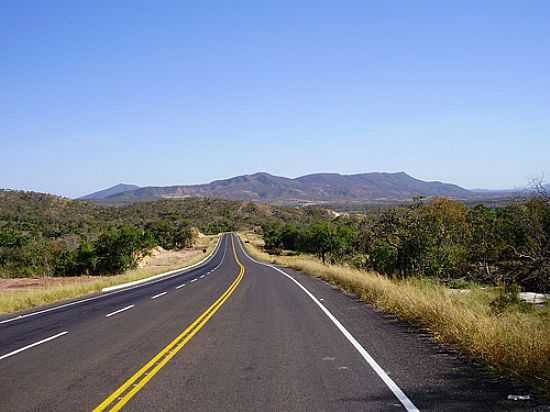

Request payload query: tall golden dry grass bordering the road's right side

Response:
[241,233,550,396]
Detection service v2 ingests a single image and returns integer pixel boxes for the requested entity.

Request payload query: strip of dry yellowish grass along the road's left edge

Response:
[0,236,218,314]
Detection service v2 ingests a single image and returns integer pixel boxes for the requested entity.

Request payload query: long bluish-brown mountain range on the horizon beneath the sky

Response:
[85,172,476,203]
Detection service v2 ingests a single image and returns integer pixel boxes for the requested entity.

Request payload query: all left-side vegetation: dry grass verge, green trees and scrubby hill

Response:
[0,190,327,313]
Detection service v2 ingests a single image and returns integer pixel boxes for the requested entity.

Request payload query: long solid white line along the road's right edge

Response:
[238,235,419,412]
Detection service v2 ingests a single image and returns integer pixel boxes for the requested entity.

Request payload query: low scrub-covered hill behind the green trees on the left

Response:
[0,189,328,239]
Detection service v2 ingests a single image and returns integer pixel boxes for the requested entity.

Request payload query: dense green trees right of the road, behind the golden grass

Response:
[263,197,550,292]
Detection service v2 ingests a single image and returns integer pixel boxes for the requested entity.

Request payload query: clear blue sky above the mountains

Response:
[0,0,550,196]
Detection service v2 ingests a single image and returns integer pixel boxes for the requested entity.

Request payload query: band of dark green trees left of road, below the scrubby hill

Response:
[0,221,194,277]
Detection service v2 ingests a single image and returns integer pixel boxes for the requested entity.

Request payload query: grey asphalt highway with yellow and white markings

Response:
[0,234,548,411]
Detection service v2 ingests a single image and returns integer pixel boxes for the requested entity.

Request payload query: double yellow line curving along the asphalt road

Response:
[94,236,244,412]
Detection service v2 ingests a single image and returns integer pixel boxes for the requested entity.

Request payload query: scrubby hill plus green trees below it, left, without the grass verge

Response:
[0,190,325,277]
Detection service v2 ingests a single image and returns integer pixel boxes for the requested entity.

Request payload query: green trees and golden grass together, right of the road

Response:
[243,192,550,395]
